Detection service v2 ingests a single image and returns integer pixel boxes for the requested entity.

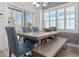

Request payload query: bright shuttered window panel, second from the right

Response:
[57,9,64,30]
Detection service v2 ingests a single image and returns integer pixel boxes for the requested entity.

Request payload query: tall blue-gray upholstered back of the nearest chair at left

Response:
[5,27,19,55]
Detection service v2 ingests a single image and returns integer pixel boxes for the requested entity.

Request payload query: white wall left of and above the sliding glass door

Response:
[0,2,36,50]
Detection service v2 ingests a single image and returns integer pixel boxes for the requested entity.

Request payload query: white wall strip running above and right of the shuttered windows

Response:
[44,2,79,32]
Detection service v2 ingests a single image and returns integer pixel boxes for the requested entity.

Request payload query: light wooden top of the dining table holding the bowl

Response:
[17,31,59,40]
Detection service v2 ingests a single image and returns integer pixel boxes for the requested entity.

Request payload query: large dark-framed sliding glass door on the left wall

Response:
[8,6,33,31]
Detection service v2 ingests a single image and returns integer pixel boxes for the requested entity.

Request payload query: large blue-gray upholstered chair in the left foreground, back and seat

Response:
[5,27,34,57]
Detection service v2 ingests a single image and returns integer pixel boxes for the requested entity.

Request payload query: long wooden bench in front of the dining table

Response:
[33,38,68,57]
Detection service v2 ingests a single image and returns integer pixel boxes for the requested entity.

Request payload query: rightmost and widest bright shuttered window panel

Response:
[66,7,75,30]
